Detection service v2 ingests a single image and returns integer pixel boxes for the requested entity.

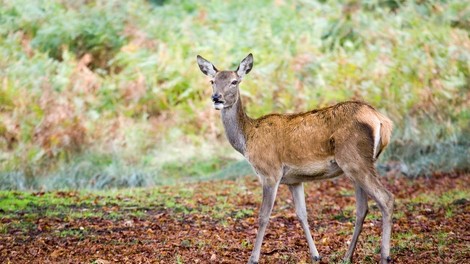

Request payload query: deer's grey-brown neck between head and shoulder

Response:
[222,95,250,155]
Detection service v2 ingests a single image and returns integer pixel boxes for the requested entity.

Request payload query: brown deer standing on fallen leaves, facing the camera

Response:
[197,53,394,264]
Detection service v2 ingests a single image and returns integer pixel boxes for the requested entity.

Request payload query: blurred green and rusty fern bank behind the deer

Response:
[0,0,470,189]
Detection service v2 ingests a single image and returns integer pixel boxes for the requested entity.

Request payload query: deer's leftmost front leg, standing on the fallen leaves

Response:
[248,182,279,264]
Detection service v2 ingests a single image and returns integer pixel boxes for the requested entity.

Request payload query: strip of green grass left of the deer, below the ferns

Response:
[0,175,254,225]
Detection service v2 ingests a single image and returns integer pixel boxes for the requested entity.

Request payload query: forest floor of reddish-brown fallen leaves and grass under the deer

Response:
[0,174,470,264]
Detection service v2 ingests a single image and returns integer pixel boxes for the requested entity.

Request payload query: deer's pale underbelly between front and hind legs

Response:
[281,159,343,184]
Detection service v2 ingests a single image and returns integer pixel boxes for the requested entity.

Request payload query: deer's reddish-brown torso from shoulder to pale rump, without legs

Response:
[245,101,391,184]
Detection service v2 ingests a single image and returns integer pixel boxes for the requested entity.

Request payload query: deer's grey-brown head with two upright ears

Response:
[197,53,253,110]
